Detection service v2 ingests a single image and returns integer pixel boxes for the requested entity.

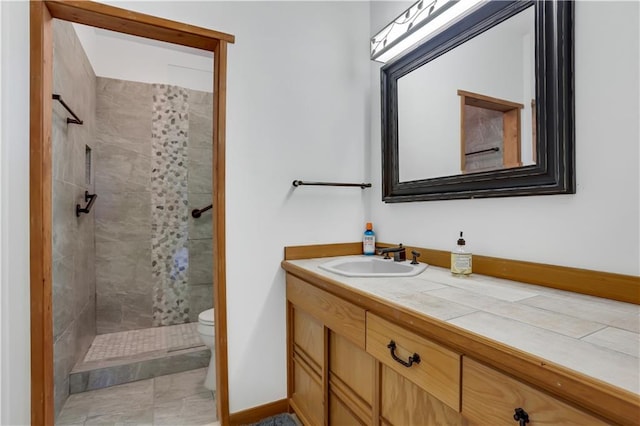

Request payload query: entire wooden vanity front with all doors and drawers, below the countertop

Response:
[287,273,607,426]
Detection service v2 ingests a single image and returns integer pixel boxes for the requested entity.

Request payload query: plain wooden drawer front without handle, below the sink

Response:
[287,274,365,349]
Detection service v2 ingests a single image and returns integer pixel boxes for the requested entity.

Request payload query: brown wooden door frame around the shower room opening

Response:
[29,0,235,425]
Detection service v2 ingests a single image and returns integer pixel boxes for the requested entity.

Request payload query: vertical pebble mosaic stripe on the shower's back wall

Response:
[151,84,189,326]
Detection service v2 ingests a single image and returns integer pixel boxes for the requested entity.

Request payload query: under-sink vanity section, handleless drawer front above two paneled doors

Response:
[287,274,376,426]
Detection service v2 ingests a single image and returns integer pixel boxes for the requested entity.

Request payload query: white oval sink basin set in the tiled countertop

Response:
[319,256,427,277]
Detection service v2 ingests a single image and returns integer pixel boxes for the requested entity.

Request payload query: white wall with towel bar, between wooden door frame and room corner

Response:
[96,2,370,412]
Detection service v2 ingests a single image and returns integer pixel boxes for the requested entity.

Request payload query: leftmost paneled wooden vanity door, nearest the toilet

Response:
[289,306,324,426]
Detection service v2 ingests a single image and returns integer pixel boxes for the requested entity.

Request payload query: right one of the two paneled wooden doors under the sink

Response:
[329,332,376,425]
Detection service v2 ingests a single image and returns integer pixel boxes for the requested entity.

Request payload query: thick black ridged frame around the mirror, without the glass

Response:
[380,0,576,203]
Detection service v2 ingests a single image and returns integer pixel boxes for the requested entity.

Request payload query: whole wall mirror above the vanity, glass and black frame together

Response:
[381,0,575,202]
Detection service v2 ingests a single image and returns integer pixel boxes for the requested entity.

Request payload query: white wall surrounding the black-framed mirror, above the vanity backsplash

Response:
[371,2,640,275]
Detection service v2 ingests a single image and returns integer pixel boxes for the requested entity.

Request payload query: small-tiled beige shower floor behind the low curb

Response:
[83,323,202,362]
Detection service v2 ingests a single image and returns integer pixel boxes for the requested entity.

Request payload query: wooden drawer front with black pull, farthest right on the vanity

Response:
[462,357,606,426]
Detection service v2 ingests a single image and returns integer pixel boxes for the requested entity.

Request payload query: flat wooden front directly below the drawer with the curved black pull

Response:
[380,364,465,426]
